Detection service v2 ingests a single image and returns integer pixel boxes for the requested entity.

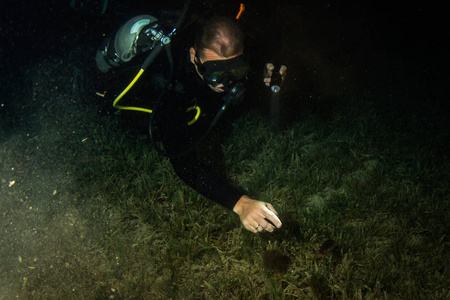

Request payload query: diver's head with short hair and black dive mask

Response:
[189,17,250,92]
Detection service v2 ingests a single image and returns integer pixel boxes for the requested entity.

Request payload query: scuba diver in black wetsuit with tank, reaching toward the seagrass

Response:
[96,7,286,233]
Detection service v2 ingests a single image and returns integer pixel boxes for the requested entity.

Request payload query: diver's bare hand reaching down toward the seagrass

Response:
[233,195,281,233]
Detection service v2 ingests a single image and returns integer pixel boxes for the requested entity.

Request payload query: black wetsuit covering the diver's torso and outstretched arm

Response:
[152,49,244,210]
